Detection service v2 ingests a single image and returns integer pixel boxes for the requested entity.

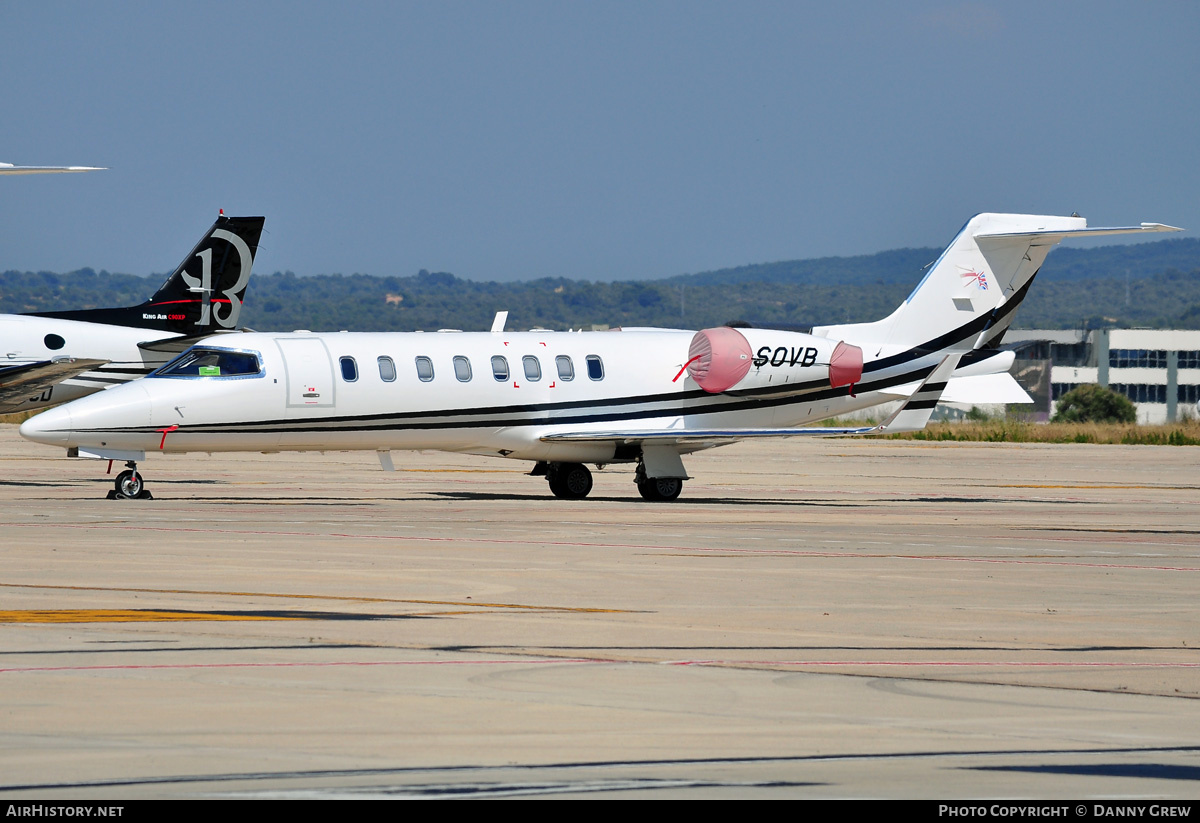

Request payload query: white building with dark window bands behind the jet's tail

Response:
[1004,329,1200,423]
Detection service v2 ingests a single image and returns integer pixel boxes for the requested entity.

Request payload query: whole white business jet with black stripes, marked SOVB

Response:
[20,214,1177,500]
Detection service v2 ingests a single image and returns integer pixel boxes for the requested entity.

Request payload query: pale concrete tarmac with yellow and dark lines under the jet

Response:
[0,426,1200,803]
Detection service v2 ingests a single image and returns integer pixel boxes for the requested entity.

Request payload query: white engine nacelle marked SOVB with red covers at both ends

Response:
[688,326,863,396]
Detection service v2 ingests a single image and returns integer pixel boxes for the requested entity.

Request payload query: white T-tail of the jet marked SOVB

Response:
[814,214,1180,360]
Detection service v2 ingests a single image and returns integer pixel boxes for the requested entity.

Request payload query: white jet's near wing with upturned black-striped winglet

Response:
[541,354,962,447]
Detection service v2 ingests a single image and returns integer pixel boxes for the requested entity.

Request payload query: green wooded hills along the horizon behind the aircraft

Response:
[0,239,1200,331]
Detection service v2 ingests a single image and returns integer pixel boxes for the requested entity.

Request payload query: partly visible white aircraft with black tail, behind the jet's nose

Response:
[0,215,263,414]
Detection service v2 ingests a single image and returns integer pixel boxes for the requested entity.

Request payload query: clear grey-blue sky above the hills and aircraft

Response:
[0,0,1200,280]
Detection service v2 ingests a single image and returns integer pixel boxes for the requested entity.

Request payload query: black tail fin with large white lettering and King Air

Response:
[31,215,265,336]
